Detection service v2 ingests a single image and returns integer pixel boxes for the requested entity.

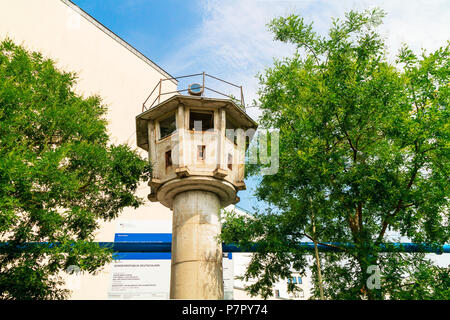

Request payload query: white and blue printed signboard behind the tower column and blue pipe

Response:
[108,220,234,300]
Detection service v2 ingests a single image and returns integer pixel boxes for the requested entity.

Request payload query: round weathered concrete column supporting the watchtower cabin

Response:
[170,190,223,300]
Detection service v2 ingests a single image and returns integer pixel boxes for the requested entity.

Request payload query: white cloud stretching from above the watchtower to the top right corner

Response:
[162,0,450,120]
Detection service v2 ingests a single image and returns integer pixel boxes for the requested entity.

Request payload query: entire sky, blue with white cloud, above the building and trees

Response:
[72,0,450,218]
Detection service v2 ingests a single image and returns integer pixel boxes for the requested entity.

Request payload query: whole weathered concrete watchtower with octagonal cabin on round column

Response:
[136,74,257,299]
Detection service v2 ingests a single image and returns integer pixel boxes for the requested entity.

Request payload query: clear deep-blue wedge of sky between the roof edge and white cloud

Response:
[73,0,201,69]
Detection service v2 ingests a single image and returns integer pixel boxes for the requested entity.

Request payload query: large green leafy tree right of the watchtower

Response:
[222,9,450,299]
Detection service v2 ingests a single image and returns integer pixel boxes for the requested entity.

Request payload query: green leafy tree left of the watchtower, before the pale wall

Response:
[0,39,150,299]
